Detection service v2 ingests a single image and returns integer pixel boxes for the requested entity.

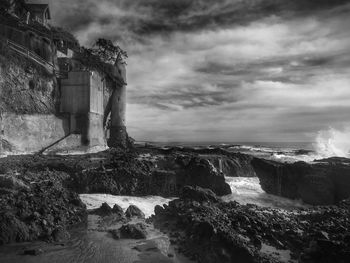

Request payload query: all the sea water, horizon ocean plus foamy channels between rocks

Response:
[81,128,350,215]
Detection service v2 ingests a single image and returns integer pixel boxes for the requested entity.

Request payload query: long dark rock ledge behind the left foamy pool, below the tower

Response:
[69,151,231,196]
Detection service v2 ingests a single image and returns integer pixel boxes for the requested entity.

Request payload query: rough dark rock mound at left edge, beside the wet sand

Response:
[0,171,86,244]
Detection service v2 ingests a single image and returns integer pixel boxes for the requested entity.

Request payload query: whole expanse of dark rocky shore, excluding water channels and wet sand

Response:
[0,147,350,262]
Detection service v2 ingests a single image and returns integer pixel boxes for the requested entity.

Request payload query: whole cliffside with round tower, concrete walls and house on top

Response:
[0,4,128,155]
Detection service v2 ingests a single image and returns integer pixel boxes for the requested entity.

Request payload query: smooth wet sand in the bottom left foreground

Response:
[0,215,191,263]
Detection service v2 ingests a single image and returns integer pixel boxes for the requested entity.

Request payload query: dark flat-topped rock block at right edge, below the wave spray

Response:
[252,158,350,205]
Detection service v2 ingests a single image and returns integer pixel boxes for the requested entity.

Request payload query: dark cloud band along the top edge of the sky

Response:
[53,0,348,40]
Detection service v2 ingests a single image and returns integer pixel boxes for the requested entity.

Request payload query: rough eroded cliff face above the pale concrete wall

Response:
[0,46,59,114]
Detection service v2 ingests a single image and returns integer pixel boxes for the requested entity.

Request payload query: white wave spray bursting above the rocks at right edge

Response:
[315,126,350,158]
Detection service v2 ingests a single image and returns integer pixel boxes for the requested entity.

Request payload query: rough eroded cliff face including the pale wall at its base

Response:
[0,45,61,155]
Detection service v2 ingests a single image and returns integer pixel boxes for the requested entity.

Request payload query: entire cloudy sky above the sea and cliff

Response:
[44,0,350,142]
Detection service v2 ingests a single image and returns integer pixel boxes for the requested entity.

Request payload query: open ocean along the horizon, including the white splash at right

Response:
[139,127,350,162]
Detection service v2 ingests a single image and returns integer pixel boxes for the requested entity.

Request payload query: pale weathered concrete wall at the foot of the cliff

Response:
[0,113,69,154]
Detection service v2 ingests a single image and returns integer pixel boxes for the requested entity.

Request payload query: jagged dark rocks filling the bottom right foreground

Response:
[153,189,350,263]
